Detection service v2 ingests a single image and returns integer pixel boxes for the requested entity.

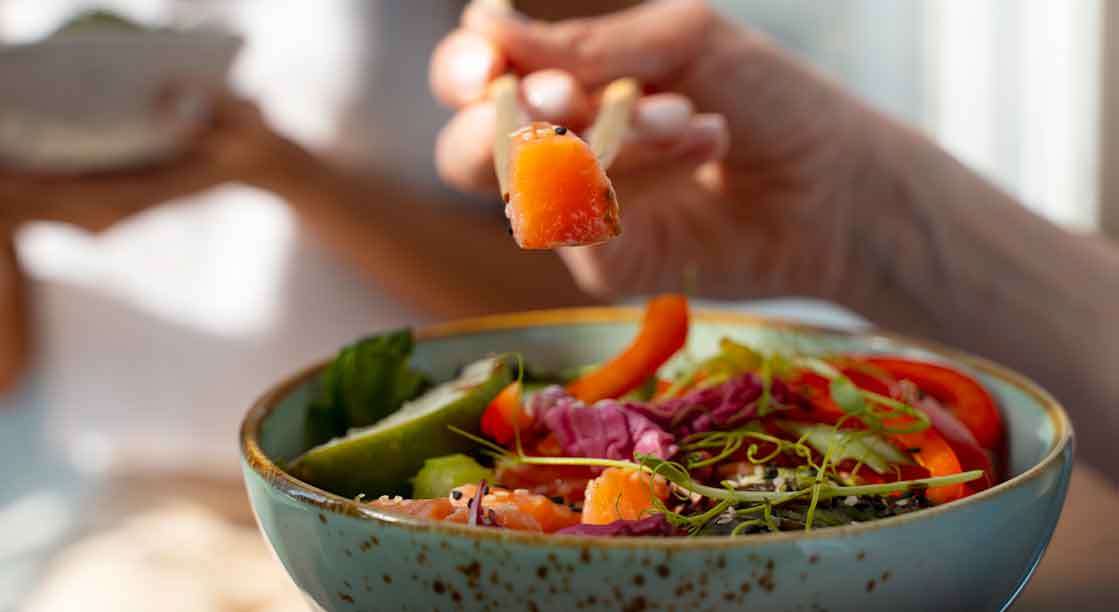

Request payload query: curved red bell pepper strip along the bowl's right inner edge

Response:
[866,357,1004,450]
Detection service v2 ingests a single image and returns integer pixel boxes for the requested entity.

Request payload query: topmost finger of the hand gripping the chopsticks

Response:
[462,0,718,88]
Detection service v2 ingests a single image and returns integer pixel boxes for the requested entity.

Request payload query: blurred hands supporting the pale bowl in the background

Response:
[0,88,302,392]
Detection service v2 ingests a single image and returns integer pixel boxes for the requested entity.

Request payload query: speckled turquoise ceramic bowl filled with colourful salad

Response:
[241,295,1072,611]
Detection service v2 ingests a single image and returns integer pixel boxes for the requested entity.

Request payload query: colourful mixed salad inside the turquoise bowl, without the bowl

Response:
[290,295,1003,537]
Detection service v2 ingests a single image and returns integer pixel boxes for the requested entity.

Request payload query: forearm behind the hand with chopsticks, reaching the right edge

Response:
[848,117,1119,479]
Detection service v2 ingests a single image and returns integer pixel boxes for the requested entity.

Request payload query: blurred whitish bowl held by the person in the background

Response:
[0,29,242,172]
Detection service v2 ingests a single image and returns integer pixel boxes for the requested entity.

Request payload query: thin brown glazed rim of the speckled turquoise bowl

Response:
[241,307,1073,550]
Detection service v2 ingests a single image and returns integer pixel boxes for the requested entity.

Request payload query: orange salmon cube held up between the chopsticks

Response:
[505,122,621,248]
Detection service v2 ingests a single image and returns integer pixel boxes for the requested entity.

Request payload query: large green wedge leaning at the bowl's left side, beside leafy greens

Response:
[288,357,516,498]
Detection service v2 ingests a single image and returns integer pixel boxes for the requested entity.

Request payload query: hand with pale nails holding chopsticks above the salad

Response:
[431,0,882,298]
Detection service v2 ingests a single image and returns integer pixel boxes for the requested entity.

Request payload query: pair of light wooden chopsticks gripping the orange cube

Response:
[489,64,640,194]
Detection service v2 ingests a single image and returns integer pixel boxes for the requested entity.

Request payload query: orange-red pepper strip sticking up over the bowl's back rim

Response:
[567,294,688,404]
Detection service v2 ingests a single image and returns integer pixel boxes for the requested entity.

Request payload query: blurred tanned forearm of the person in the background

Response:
[262,146,591,319]
